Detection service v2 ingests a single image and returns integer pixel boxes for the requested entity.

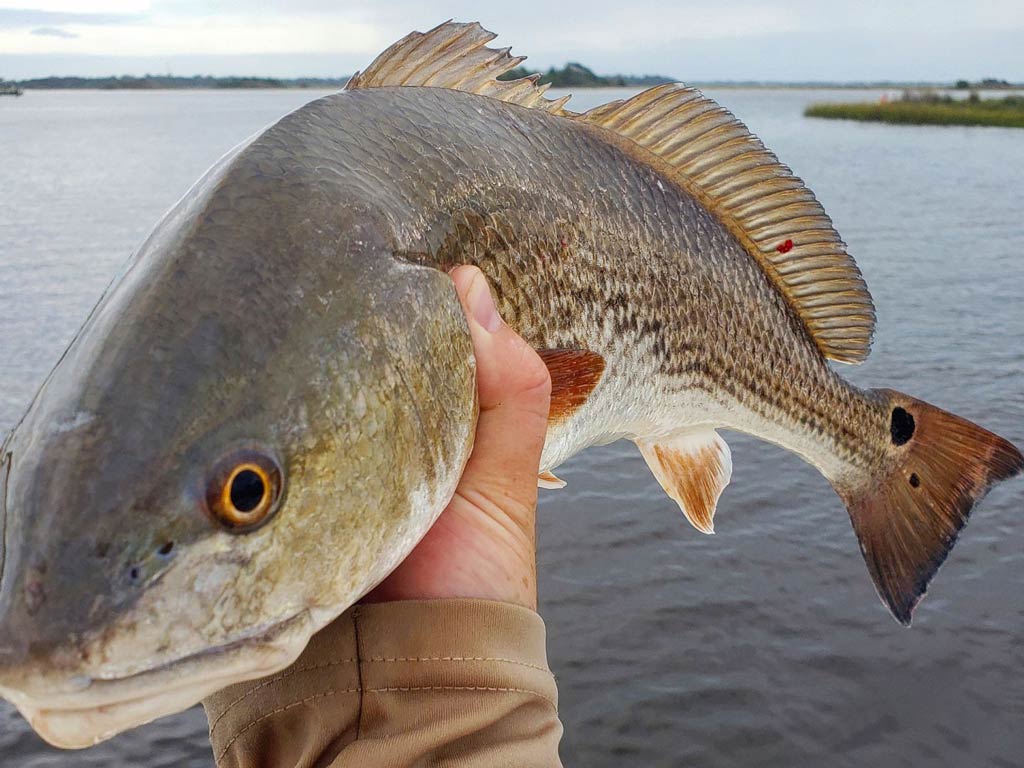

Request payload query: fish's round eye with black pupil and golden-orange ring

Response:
[206,451,284,534]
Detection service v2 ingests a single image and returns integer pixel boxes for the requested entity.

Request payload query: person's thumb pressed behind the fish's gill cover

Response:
[452,266,551,526]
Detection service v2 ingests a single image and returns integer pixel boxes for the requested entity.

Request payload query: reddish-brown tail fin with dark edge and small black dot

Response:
[833,390,1024,627]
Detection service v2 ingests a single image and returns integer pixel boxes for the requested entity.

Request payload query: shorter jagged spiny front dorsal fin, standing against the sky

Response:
[345,22,569,115]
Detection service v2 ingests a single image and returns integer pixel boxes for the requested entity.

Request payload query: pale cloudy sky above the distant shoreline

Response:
[0,0,1024,82]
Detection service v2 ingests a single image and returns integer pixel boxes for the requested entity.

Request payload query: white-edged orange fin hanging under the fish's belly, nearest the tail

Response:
[636,429,732,534]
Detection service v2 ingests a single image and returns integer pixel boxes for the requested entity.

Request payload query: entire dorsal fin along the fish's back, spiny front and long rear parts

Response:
[345,22,874,362]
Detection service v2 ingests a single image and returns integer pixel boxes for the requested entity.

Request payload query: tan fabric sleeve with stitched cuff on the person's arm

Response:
[204,600,562,768]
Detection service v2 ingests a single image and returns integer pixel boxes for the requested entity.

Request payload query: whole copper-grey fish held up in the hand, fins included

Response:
[0,24,1024,746]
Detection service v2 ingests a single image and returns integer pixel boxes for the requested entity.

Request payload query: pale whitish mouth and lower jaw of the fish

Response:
[0,610,313,750]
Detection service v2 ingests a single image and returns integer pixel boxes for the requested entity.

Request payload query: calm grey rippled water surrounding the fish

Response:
[0,90,1024,768]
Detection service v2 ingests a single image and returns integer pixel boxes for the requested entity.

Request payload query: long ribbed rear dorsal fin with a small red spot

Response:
[580,84,874,362]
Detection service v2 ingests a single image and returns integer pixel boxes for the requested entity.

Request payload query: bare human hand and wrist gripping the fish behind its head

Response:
[365,266,551,610]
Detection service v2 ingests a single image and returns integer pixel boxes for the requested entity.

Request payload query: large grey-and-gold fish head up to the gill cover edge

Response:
[0,142,476,748]
